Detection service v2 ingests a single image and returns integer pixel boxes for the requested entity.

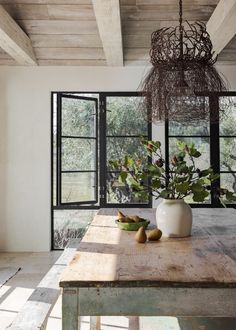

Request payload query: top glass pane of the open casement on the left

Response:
[62,97,96,137]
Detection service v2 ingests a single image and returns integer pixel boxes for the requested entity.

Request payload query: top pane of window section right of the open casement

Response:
[107,96,147,136]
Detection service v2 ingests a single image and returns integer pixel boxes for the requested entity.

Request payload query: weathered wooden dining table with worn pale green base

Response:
[60,208,236,330]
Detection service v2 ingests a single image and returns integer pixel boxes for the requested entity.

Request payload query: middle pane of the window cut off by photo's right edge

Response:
[220,138,236,172]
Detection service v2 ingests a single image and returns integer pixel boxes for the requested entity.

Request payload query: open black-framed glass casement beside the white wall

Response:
[57,93,98,205]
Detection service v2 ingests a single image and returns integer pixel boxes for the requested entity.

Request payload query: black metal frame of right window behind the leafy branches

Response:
[165,91,236,208]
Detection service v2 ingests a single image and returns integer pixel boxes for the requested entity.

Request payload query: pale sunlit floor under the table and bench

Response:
[0,251,236,330]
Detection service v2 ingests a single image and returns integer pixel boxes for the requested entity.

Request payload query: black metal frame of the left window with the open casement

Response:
[51,91,152,215]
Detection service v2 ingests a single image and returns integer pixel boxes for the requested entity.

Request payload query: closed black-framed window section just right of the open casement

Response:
[101,93,151,207]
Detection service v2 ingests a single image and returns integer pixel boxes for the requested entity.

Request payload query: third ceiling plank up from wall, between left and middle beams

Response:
[29,34,102,48]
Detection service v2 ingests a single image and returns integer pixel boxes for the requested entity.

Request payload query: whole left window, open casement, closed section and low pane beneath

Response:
[51,92,151,249]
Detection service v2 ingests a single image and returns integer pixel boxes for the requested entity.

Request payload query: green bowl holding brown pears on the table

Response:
[115,211,150,231]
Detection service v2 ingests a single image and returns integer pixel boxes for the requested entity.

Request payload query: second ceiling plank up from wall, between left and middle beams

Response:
[34,48,105,60]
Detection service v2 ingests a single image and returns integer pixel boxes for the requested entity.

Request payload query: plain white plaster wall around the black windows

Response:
[0,63,236,251]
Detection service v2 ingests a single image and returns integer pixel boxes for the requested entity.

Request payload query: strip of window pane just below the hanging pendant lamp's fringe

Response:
[169,120,210,136]
